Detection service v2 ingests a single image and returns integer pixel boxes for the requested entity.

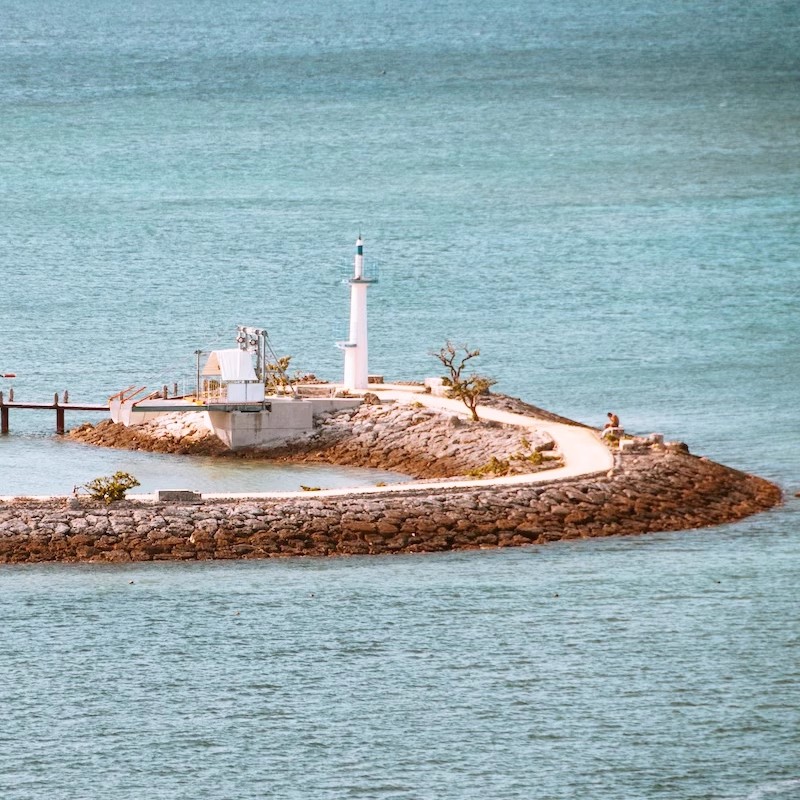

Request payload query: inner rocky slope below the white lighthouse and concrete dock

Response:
[69,402,561,478]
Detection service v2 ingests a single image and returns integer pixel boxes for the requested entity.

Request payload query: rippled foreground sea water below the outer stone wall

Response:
[0,516,800,798]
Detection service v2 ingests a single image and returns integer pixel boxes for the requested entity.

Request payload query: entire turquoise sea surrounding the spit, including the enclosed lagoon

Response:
[0,0,800,800]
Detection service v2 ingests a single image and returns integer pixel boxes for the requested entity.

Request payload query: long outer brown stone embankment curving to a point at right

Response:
[0,451,781,563]
